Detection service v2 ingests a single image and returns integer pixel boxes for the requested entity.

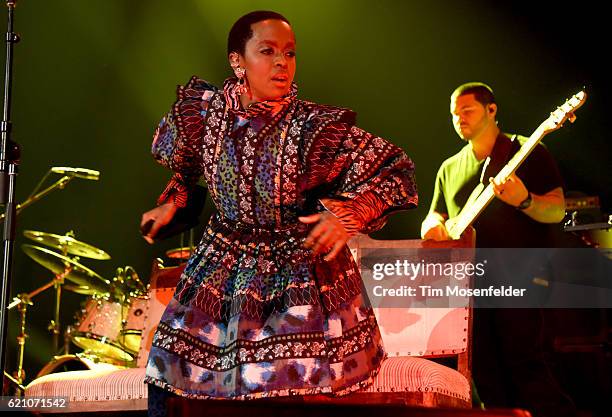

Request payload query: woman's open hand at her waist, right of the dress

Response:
[298,211,349,261]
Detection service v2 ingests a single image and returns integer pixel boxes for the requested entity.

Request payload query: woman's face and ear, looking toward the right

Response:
[230,19,295,101]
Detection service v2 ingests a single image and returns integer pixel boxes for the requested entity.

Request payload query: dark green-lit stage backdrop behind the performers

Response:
[0,0,612,404]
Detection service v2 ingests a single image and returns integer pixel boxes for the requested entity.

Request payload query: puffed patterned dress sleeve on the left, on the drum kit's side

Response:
[151,76,217,207]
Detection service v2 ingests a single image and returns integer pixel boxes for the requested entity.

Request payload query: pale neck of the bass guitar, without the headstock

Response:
[448,125,546,239]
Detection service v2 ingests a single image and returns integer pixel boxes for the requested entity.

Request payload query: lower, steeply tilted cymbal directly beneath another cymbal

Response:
[21,244,110,293]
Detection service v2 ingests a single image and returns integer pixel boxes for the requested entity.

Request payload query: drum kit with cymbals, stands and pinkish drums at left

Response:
[6,230,147,388]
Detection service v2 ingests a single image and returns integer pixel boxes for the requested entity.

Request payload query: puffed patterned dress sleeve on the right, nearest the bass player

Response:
[305,106,418,235]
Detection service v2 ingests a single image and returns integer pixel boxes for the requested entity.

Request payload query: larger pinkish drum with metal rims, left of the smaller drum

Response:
[72,296,134,361]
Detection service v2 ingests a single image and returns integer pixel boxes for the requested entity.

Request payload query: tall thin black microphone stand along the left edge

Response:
[0,0,19,393]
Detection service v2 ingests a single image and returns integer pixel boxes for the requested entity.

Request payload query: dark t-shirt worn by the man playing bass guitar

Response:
[430,134,563,248]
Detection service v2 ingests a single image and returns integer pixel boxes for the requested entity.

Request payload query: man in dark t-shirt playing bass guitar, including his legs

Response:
[421,82,575,417]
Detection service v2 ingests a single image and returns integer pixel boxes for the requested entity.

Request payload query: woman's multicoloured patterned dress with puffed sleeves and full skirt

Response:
[146,77,417,399]
